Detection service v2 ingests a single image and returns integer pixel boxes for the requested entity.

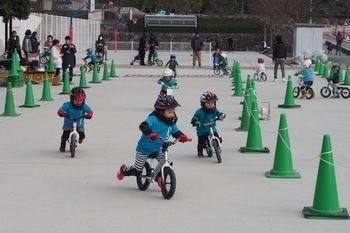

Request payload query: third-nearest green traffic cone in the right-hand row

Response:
[239,101,270,153]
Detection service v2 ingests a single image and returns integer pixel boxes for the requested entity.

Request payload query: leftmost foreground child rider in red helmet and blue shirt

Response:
[57,87,93,152]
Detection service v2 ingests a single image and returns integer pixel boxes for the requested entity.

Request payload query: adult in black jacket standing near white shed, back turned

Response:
[272,35,287,82]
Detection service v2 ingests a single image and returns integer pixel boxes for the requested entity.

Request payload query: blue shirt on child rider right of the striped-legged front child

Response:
[191,107,223,136]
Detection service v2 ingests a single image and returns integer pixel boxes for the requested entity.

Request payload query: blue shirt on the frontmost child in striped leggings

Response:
[136,114,181,156]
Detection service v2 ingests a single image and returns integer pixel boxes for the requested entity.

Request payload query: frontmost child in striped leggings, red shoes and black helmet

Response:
[117,95,191,185]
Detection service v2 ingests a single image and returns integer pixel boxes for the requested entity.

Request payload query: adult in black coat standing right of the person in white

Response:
[61,36,77,82]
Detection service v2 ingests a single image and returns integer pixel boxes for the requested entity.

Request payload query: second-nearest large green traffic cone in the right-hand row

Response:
[265,113,301,178]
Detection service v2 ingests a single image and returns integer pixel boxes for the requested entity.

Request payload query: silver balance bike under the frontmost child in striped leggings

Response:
[136,137,192,199]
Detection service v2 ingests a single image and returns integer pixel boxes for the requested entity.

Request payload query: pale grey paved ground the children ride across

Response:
[0,52,350,233]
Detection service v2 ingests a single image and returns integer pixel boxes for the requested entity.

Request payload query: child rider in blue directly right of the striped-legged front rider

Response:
[191,91,226,157]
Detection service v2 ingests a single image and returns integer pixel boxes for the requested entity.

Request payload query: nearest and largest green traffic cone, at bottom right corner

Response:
[302,134,349,219]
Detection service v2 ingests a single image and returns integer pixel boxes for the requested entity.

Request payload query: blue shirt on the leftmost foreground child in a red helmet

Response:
[60,102,92,130]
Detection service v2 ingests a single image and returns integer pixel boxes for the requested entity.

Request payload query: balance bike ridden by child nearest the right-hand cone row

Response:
[204,117,222,163]
